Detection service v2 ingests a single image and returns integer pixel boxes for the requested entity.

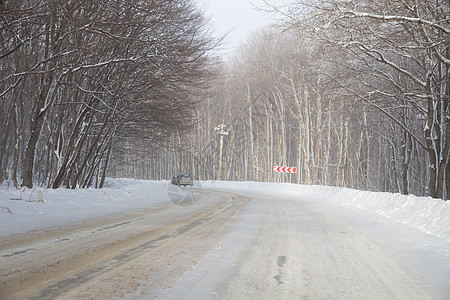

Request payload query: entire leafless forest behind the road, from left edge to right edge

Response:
[0,0,450,199]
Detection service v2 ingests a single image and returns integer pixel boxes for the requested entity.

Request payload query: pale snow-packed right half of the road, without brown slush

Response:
[152,191,449,299]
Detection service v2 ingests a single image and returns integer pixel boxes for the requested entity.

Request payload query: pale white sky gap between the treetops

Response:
[197,0,286,54]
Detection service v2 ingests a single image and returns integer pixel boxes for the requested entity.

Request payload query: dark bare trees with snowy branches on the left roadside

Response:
[0,0,215,188]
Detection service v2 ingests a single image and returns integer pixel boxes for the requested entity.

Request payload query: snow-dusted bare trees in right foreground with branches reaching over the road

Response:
[273,0,450,199]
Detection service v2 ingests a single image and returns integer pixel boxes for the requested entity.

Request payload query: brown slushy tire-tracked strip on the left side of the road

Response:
[0,193,246,299]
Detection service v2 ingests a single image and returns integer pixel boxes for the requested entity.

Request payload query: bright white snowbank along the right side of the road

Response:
[203,182,450,242]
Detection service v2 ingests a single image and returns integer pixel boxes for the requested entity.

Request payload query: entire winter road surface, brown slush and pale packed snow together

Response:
[0,191,448,299]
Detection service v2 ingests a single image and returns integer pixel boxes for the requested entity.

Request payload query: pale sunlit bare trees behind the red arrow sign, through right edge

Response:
[125,0,450,199]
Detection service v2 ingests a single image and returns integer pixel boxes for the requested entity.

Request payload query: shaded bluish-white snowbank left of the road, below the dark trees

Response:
[0,179,170,237]
